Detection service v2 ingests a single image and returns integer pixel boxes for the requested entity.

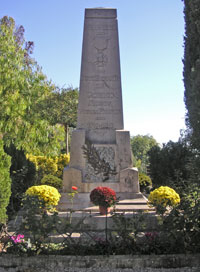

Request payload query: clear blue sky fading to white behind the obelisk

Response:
[0,0,185,144]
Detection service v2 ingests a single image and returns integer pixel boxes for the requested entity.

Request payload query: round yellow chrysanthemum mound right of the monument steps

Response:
[148,186,180,214]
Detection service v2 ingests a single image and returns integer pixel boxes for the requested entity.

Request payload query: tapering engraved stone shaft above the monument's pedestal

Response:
[77,9,123,129]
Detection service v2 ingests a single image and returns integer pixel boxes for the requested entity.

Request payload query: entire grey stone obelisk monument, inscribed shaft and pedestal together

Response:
[63,8,139,208]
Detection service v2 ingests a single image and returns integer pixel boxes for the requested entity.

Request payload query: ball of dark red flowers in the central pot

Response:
[90,186,117,215]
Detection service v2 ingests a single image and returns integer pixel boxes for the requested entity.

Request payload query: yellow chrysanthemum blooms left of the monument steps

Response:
[26,185,61,208]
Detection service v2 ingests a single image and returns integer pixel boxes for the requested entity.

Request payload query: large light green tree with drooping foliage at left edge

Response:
[0,16,61,153]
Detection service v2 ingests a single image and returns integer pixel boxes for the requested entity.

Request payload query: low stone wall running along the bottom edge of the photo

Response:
[0,254,200,272]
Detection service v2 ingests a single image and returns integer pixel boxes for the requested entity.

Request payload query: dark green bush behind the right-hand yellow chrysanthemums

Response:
[148,139,193,188]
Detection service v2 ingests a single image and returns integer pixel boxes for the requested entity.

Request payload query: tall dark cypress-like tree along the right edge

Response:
[183,0,200,150]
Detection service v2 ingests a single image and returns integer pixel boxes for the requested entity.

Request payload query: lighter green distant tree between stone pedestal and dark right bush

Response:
[131,135,158,174]
